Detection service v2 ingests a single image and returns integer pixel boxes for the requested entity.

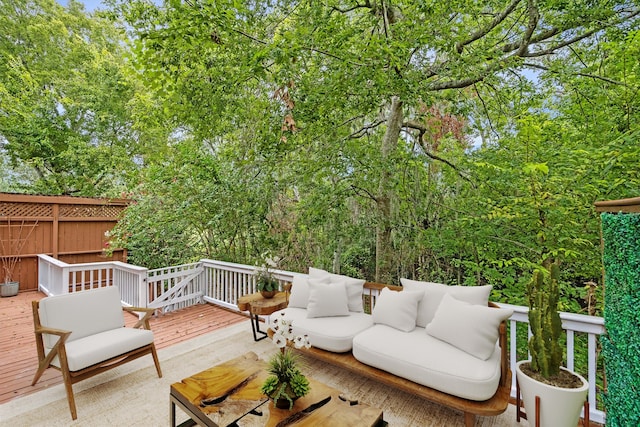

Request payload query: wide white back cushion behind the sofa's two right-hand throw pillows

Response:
[400,278,491,328]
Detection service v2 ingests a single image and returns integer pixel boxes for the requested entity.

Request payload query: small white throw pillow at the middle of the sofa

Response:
[371,288,424,332]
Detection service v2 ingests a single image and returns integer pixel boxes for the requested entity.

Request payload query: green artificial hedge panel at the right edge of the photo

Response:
[601,213,640,427]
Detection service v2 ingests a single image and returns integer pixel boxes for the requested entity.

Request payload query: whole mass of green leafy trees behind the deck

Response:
[0,0,640,314]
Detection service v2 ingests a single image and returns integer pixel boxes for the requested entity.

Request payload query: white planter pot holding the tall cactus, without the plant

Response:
[516,360,589,427]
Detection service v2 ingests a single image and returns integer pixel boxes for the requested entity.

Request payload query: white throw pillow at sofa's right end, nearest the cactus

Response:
[426,295,513,360]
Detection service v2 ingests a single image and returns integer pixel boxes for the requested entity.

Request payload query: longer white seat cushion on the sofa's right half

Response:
[353,325,500,401]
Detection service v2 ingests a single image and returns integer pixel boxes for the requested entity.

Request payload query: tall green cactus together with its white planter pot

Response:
[516,262,589,427]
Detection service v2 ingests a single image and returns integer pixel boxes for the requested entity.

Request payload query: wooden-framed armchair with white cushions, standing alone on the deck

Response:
[32,286,162,420]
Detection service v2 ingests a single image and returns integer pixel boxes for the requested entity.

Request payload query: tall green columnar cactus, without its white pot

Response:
[527,263,562,378]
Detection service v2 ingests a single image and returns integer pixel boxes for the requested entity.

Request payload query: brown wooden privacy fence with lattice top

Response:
[0,193,129,291]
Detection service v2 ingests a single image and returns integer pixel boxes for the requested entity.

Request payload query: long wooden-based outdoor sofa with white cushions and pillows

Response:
[272,268,512,426]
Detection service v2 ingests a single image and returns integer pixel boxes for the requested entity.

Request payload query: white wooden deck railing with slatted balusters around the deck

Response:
[38,255,606,424]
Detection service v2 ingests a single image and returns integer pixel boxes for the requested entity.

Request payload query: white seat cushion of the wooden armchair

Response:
[45,328,153,372]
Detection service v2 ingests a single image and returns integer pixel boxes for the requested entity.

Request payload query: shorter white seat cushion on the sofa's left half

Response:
[271,307,372,353]
